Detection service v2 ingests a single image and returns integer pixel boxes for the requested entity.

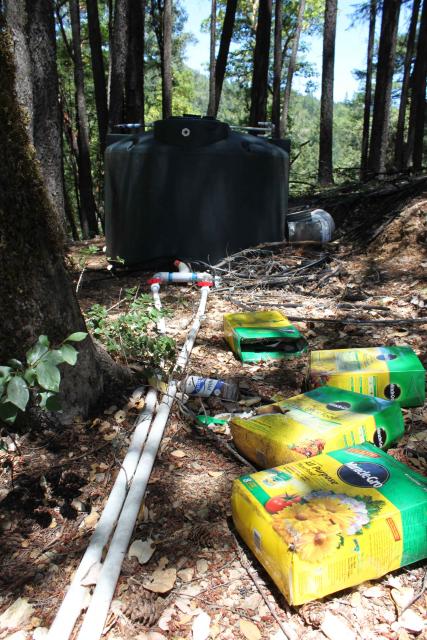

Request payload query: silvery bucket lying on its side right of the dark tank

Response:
[286,209,335,244]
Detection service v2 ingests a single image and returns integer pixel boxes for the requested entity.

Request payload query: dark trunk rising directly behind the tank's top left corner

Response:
[109,0,129,130]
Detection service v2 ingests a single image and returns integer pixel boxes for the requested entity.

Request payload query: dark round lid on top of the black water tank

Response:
[154,116,230,149]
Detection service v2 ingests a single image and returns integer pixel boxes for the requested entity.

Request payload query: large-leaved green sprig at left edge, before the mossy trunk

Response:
[0,331,87,424]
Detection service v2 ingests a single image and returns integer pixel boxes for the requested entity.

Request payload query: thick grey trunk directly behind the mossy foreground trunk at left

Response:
[7,0,67,230]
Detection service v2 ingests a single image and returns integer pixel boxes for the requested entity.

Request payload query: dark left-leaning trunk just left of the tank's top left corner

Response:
[86,0,108,154]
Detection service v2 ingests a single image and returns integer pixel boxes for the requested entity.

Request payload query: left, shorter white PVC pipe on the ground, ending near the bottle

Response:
[47,389,157,640]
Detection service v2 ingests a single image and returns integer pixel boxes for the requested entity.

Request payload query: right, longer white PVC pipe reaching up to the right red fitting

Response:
[77,286,209,640]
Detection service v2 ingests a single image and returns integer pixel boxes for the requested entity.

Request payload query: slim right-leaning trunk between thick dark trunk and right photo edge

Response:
[394,0,421,171]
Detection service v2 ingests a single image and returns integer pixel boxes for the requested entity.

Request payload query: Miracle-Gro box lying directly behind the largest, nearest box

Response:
[230,387,404,469]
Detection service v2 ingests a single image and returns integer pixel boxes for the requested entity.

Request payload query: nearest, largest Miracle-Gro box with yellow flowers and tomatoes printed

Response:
[232,444,427,605]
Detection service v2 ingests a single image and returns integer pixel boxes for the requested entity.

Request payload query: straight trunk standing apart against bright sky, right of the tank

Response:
[319,0,337,184]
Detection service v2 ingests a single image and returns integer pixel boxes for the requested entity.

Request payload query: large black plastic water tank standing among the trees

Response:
[105,117,289,265]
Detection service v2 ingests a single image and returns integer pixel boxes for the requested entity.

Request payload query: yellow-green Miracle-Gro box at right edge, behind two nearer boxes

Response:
[309,346,426,407]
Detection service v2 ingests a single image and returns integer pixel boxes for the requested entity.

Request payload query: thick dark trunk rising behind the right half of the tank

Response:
[249,0,272,127]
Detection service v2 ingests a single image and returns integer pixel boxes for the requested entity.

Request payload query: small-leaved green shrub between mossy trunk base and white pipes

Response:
[87,287,175,368]
